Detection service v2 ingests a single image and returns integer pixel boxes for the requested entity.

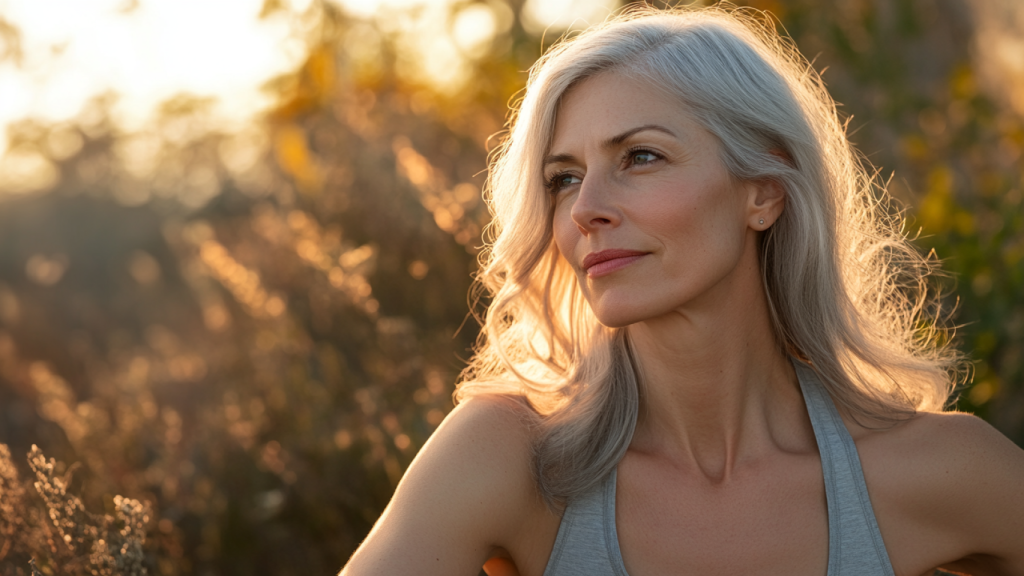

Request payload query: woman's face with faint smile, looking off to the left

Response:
[544,73,768,327]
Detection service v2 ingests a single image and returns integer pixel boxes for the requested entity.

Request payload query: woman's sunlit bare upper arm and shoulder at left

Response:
[342,397,537,576]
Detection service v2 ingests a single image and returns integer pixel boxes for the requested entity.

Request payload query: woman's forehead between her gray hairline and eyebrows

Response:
[551,72,710,147]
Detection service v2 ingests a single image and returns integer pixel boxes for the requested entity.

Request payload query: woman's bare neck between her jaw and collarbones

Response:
[628,251,814,483]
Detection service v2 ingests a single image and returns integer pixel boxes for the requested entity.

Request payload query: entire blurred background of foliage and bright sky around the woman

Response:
[0,0,1024,575]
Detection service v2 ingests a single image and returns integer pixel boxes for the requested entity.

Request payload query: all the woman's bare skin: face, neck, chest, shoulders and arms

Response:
[342,73,1024,576]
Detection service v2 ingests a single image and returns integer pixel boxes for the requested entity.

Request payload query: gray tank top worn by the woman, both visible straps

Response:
[544,361,895,576]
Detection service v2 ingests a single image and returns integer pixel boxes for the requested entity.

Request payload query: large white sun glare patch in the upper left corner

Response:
[0,0,308,151]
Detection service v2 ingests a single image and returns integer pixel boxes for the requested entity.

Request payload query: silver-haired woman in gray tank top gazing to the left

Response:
[343,5,1024,576]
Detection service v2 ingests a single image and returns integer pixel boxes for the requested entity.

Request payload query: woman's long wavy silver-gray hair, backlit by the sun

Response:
[456,8,961,504]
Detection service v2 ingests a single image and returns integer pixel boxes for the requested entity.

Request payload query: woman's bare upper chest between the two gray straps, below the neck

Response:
[615,456,828,576]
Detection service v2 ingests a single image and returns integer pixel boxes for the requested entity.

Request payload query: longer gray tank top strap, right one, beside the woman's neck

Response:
[793,359,895,576]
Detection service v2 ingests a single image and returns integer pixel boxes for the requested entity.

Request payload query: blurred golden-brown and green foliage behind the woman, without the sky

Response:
[0,0,1024,574]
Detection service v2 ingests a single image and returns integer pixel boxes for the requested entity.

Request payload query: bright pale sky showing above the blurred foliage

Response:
[0,0,614,154]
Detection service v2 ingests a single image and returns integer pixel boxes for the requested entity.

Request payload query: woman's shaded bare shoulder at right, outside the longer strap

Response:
[854,412,1024,574]
